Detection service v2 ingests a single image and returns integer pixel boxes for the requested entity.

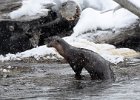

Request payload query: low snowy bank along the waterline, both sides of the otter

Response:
[0,37,139,64]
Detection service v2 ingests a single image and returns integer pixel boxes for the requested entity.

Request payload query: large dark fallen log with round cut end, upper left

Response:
[0,0,80,54]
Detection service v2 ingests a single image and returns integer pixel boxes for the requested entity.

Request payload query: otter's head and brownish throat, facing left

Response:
[47,36,66,56]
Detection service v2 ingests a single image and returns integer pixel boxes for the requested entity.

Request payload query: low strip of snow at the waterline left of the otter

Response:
[0,45,62,61]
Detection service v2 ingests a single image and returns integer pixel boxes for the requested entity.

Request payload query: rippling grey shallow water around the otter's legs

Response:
[0,59,140,100]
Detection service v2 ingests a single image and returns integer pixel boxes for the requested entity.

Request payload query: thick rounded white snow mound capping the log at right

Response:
[72,8,138,37]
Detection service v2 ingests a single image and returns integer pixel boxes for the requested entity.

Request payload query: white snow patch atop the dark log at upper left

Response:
[9,0,55,19]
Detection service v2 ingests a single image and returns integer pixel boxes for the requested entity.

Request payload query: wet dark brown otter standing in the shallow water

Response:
[47,36,114,80]
